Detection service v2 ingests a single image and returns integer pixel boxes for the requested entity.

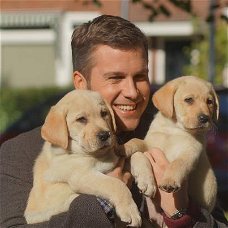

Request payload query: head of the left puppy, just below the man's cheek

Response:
[41,90,116,156]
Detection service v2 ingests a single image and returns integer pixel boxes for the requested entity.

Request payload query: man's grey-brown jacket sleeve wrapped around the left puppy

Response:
[0,128,112,228]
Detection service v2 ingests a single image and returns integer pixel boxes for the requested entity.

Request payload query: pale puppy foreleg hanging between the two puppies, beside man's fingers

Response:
[130,152,156,197]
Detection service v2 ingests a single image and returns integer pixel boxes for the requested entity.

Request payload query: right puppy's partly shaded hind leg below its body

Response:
[189,152,217,212]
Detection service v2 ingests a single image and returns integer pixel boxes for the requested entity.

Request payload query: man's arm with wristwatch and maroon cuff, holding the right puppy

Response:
[145,149,228,228]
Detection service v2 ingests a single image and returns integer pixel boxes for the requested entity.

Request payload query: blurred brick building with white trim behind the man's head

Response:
[0,0,225,87]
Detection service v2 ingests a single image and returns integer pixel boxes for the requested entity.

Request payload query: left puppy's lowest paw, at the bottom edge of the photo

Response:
[116,201,142,227]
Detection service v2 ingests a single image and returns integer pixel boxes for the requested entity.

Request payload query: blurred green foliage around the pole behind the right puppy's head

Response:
[184,21,228,85]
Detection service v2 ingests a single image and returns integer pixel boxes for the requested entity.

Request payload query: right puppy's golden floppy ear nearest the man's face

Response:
[152,81,177,118]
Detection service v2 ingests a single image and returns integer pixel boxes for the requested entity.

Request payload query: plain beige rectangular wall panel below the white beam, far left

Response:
[1,44,55,88]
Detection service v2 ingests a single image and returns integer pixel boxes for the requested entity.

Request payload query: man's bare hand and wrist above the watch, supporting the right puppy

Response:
[145,148,189,217]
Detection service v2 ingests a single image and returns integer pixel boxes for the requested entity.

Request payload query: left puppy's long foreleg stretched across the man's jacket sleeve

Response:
[69,170,141,227]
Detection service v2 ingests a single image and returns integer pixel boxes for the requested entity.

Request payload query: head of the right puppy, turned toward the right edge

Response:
[153,76,219,130]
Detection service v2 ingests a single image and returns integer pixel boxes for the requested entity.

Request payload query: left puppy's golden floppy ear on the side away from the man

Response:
[41,106,68,149]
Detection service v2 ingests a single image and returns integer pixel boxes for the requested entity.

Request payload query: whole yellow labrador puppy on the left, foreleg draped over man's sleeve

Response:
[24,90,155,226]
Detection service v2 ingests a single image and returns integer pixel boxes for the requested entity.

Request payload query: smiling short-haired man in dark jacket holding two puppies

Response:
[0,15,228,228]
